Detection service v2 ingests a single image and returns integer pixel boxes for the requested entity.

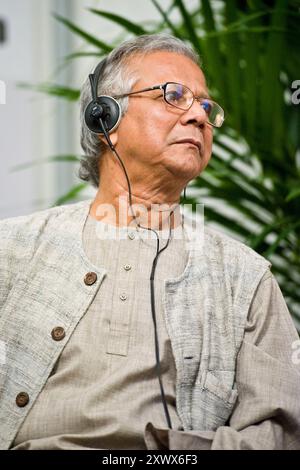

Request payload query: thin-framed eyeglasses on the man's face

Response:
[114,82,224,127]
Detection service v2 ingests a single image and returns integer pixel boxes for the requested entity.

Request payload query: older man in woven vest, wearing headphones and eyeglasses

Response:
[0,35,300,449]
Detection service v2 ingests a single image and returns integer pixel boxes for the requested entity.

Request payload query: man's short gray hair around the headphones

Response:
[78,33,200,188]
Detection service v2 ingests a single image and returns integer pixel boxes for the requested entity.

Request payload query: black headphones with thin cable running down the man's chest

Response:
[84,58,186,429]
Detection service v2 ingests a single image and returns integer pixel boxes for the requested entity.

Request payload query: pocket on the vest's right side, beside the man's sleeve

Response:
[191,370,238,431]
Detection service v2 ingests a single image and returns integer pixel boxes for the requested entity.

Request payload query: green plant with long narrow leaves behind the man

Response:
[13,0,300,325]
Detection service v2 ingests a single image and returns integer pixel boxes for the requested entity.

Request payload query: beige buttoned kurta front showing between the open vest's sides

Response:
[13,216,188,449]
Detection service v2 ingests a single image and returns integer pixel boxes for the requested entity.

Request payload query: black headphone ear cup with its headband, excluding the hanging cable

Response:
[84,59,121,134]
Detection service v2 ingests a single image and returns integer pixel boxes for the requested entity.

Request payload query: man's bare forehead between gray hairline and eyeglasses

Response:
[126,51,207,94]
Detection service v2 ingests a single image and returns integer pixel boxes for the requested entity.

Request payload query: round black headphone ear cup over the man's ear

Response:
[84,95,121,134]
